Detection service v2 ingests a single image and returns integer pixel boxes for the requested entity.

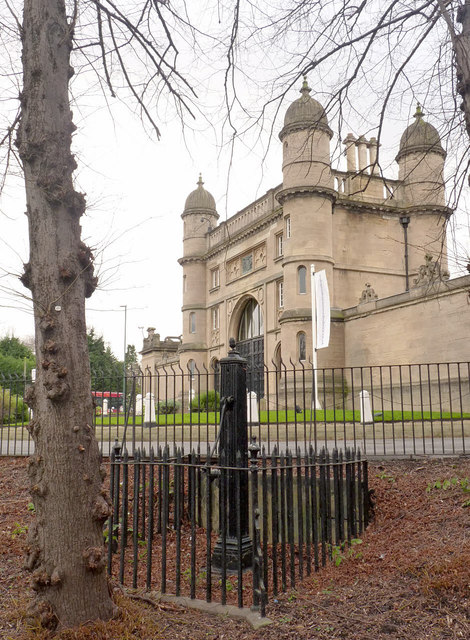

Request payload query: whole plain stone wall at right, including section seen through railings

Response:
[344,276,470,411]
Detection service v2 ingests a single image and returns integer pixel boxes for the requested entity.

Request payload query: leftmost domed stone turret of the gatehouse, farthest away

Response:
[179,176,219,371]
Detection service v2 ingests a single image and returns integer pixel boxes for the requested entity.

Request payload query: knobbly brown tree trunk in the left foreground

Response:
[17,0,114,627]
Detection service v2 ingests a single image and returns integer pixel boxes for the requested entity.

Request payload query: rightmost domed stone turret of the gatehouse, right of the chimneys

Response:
[395,104,451,272]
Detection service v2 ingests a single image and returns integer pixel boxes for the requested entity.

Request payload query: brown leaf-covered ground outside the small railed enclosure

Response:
[0,458,470,640]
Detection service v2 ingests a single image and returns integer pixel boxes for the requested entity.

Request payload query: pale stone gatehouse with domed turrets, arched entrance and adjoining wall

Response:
[142,81,470,392]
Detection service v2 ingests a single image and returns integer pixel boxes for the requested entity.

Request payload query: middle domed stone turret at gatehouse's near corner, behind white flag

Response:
[277,79,336,368]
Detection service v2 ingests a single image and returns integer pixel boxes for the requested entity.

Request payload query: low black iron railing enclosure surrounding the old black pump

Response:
[105,443,371,615]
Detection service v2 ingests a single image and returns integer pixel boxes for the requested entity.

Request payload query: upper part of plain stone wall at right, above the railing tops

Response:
[344,276,470,367]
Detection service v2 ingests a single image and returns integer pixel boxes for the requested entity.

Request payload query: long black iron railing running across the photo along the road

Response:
[0,362,470,456]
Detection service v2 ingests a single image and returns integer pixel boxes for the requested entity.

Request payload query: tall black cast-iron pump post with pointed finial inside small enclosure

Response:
[212,338,253,573]
